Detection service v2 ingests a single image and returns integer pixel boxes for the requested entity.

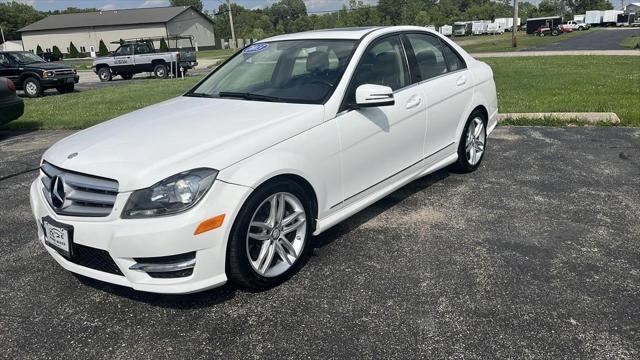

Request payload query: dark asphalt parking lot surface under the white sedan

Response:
[0,127,640,359]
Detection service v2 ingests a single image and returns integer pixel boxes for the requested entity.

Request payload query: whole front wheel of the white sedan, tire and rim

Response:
[227,180,312,290]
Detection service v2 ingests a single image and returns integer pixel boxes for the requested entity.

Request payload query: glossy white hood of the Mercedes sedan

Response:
[43,96,324,192]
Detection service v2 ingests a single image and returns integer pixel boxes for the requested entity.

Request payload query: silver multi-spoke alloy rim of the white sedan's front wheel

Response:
[246,192,307,278]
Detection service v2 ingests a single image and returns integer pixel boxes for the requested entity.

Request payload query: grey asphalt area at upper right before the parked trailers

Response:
[522,28,640,51]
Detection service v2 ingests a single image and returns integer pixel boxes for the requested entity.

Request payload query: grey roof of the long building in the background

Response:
[18,6,206,32]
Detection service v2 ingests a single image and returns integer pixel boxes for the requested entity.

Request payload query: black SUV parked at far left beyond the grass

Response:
[0,51,80,97]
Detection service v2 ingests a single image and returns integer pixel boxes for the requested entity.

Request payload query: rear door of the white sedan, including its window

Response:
[405,33,472,156]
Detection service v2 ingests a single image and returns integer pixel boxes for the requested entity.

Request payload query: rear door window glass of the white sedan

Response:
[407,34,447,81]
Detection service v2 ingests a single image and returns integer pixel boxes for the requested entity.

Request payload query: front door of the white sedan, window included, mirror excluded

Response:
[335,35,426,203]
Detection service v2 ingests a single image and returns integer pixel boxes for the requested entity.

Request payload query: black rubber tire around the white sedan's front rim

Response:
[226,179,314,291]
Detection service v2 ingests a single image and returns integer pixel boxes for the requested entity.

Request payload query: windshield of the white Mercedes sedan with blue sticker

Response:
[187,40,356,104]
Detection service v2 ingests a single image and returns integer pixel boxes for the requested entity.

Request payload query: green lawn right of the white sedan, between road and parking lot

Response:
[482,56,640,126]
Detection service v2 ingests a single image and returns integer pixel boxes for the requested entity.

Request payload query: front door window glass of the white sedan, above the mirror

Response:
[349,36,409,92]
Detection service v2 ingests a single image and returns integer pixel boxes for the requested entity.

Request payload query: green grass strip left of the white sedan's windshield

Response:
[8,76,202,130]
